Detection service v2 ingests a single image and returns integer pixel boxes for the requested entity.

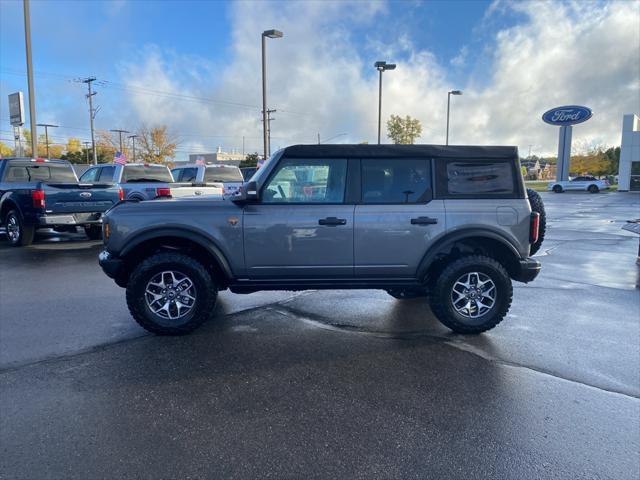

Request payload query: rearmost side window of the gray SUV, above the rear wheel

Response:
[436,159,517,198]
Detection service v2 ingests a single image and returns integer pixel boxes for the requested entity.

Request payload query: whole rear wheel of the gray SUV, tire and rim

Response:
[430,255,513,333]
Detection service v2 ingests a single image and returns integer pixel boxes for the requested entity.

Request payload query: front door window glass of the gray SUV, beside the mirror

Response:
[262,158,347,203]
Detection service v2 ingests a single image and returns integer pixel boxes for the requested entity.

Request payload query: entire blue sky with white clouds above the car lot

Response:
[0,0,640,161]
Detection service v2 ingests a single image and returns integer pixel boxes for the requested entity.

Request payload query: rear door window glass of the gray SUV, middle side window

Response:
[362,158,432,204]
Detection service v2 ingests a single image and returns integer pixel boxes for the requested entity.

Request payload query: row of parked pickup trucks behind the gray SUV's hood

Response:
[0,158,242,246]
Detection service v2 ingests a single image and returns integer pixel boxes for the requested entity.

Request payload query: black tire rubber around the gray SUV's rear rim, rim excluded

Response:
[430,255,513,333]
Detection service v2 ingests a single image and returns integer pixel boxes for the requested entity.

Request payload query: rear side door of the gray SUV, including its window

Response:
[354,158,445,278]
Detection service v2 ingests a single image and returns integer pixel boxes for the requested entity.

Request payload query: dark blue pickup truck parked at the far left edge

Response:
[0,158,123,246]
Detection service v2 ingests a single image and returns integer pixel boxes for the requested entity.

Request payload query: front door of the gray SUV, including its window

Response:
[243,158,354,279]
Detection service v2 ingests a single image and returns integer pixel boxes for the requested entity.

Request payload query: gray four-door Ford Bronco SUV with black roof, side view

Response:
[99,145,544,335]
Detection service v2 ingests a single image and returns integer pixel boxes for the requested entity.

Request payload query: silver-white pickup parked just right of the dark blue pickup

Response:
[80,163,222,200]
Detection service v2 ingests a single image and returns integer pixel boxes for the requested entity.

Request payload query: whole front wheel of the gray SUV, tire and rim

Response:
[127,252,218,335]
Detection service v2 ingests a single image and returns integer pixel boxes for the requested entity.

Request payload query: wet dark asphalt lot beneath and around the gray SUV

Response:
[0,193,640,479]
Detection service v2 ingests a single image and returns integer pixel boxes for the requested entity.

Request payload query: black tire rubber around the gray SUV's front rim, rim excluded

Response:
[126,252,218,335]
